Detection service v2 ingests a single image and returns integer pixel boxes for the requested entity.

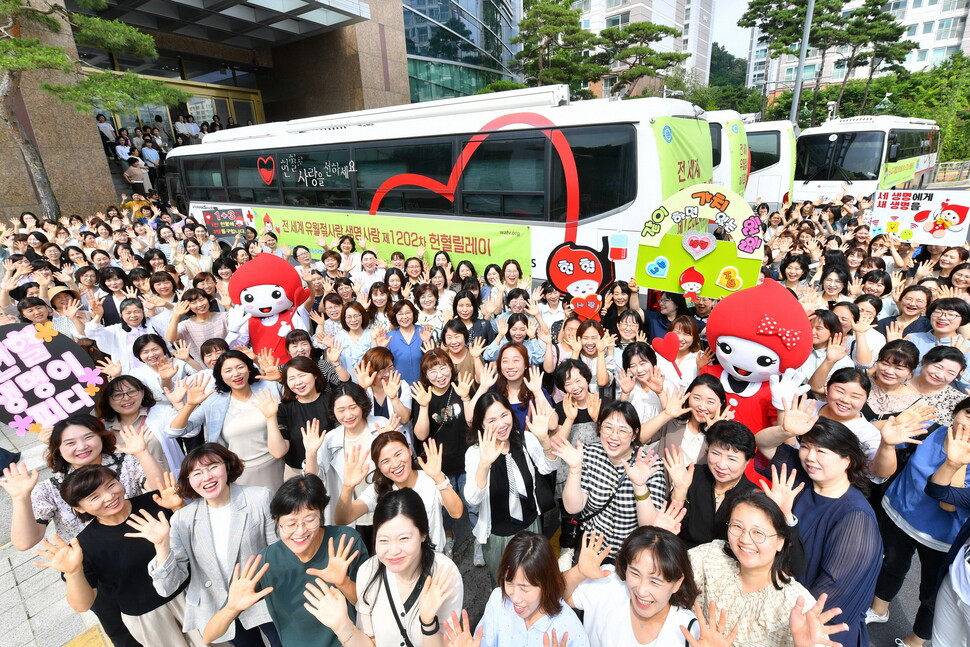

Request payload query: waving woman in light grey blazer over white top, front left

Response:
[132,443,280,647]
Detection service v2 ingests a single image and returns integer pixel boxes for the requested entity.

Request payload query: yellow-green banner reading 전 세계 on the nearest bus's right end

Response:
[651,117,714,200]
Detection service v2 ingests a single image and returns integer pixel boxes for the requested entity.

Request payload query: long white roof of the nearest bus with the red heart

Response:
[168,85,703,158]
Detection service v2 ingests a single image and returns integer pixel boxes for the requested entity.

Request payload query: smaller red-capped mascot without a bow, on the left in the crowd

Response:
[227,254,310,364]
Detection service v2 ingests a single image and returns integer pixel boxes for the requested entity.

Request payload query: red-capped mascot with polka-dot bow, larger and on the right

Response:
[701,280,812,438]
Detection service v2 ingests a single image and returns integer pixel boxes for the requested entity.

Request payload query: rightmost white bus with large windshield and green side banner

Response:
[795,115,940,200]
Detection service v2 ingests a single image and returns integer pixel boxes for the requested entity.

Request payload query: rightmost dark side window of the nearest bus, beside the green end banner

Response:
[549,124,640,222]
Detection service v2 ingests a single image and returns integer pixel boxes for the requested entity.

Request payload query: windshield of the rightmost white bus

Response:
[795,131,886,183]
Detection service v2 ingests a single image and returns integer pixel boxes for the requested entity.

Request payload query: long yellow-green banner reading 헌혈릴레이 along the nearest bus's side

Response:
[254,208,532,272]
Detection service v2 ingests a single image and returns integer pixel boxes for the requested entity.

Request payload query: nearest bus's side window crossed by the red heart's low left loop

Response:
[353,139,454,214]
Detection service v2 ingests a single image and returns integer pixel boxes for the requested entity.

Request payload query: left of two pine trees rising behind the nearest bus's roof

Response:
[512,0,609,98]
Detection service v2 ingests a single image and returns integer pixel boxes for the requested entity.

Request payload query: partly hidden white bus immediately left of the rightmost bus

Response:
[744,120,795,211]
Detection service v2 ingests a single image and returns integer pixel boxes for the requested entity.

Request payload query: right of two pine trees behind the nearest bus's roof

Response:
[599,22,690,96]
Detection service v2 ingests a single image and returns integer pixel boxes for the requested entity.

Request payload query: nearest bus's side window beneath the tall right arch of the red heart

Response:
[461,132,547,220]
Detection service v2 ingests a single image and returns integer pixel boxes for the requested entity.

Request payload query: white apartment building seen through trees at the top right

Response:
[747,0,970,94]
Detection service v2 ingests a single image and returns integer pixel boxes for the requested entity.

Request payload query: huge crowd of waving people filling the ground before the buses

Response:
[0,192,970,647]
